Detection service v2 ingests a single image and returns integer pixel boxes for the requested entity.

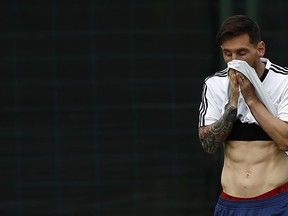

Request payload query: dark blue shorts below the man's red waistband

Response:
[214,191,288,216]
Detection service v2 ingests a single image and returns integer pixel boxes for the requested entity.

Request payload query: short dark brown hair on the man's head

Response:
[216,15,261,45]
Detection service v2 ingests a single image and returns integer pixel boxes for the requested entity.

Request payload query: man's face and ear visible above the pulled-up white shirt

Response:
[221,34,265,68]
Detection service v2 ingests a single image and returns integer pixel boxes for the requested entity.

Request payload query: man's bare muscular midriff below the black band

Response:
[221,141,288,198]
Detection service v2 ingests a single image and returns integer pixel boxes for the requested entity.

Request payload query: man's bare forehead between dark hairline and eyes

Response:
[221,34,253,50]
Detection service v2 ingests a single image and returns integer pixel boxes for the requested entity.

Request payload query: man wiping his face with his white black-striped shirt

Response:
[199,15,288,216]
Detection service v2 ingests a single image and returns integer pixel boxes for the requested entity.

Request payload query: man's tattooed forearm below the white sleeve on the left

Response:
[199,104,237,154]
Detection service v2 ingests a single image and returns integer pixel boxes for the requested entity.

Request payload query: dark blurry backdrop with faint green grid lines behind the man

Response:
[0,0,288,216]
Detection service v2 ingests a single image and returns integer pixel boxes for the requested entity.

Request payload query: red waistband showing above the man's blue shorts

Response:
[220,182,288,200]
